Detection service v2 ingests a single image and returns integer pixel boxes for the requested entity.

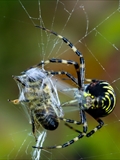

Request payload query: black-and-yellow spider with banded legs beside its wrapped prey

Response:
[33,26,116,149]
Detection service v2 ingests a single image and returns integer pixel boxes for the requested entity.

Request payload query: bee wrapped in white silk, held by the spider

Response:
[9,67,64,141]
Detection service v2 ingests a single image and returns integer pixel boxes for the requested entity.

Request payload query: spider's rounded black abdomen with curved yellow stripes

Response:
[86,80,116,118]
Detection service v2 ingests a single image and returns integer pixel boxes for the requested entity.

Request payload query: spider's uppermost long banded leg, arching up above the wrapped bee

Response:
[35,26,85,88]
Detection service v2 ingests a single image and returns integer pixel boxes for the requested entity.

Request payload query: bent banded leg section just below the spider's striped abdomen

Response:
[86,119,104,137]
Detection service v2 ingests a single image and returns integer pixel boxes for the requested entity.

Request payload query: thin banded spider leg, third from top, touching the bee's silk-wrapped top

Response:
[46,71,78,85]
